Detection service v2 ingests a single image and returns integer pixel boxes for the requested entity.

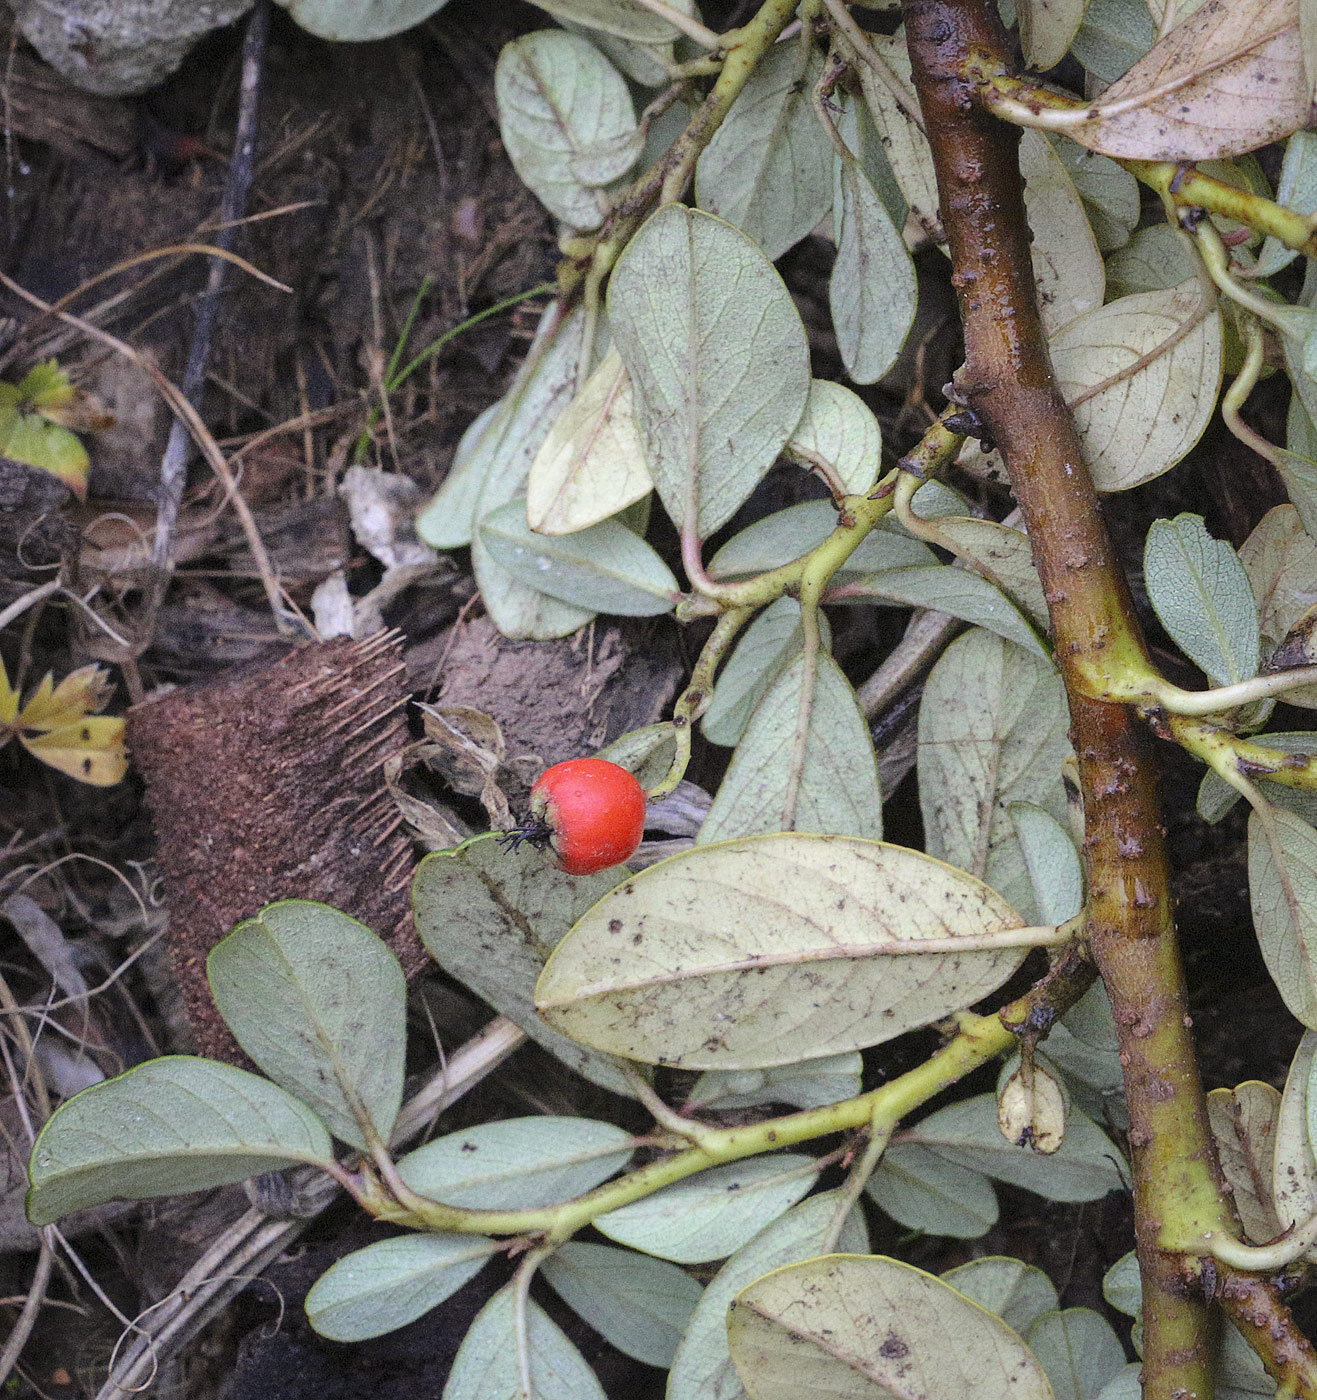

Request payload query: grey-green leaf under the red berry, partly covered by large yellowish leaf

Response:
[411,840,631,1095]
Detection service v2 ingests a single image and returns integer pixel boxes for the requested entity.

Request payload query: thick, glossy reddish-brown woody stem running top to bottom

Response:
[903,0,1313,1400]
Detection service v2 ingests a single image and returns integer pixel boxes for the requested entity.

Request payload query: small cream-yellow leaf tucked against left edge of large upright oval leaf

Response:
[526,350,654,535]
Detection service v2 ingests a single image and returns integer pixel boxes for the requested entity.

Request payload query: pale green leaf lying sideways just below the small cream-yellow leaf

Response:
[480,500,680,617]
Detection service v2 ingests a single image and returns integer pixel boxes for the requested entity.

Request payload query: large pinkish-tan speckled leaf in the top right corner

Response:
[1065,0,1311,161]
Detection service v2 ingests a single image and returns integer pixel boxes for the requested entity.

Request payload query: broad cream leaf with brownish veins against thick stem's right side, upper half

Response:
[1051,279,1222,491]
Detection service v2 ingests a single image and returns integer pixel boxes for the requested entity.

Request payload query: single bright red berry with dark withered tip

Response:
[530,759,645,875]
